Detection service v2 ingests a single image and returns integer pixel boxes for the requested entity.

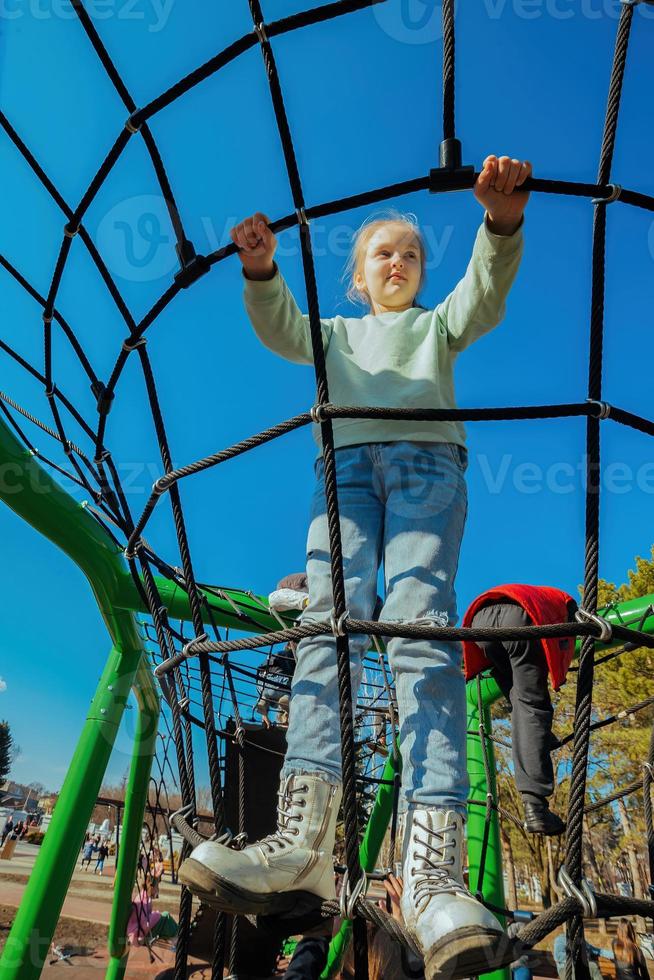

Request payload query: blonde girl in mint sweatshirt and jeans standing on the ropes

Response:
[180,156,531,977]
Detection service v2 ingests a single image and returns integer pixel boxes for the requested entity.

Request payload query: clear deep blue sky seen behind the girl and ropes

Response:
[0,0,654,787]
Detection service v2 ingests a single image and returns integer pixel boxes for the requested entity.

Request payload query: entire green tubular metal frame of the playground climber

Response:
[0,408,654,980]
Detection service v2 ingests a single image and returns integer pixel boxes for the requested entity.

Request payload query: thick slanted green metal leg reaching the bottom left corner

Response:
[0,647,141,980]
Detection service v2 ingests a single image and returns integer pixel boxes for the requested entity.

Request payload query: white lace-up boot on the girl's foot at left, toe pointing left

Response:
[179,775,342,915]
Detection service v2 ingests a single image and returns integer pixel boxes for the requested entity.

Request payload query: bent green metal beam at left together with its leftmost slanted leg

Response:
[0,420,158,980]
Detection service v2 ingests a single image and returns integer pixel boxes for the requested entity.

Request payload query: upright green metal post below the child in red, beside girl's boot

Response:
[466,678,510,980]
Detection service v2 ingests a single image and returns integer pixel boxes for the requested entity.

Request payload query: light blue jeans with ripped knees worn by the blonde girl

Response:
[283,442,468,813]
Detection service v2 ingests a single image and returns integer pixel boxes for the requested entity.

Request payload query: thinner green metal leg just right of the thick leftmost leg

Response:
[106,662,159,980]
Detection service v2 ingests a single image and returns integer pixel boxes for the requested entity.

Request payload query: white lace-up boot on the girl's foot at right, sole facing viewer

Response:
[401,808,513,980]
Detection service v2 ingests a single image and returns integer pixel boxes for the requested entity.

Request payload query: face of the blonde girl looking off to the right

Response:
[354,222,422,315]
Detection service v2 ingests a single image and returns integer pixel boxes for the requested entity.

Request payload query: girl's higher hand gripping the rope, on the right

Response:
[473,155,531,235]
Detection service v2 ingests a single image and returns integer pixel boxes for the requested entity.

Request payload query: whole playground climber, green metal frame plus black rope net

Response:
[0,0,654,980]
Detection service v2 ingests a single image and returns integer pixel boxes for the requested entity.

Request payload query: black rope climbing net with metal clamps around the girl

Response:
[0,0,654,978]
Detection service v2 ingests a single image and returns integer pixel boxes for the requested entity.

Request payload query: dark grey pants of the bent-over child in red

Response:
[471,603,554,797]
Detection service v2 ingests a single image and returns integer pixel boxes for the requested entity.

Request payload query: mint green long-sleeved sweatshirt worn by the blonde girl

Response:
[244,214,523,448]
